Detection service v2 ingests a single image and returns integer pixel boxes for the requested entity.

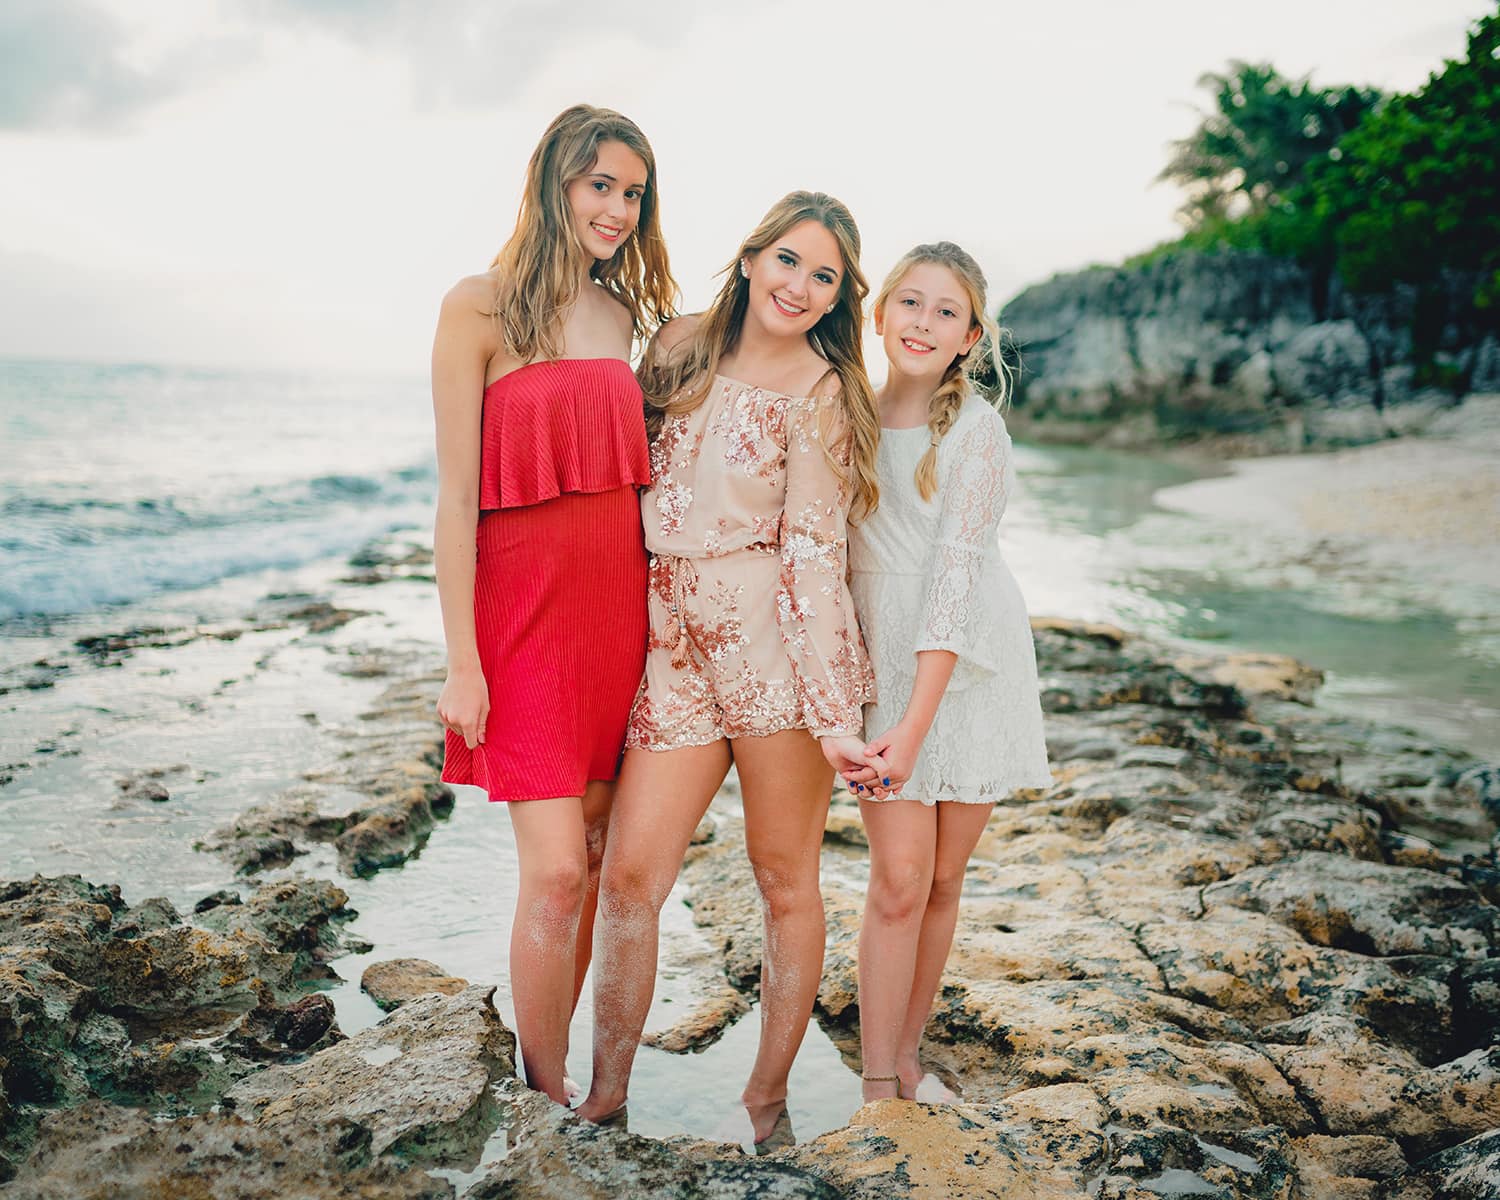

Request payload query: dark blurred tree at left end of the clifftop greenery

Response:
[1160,60,1382,231]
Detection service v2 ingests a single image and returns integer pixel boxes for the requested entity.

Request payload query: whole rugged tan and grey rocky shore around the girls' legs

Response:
[0,554,1500,1200]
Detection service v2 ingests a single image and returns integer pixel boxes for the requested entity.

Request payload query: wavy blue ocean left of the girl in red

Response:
[0,360,435,635]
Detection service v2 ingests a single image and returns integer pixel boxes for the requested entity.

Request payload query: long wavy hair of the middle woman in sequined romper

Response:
[638,192,881,521]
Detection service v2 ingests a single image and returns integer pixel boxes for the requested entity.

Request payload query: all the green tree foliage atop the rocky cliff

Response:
[1158,11,1500,324]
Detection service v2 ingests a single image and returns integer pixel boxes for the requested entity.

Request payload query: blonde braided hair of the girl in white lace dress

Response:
[875,242,1016,500]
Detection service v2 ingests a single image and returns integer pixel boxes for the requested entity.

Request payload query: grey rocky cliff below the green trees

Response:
[1002,251,1500,453]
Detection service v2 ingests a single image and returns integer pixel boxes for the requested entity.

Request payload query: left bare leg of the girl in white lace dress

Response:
[860,800,938,1100]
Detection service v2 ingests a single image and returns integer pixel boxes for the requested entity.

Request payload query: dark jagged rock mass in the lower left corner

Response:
[0,876,360,1172]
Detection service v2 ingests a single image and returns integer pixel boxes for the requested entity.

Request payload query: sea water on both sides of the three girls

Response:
[0,351,1500,755]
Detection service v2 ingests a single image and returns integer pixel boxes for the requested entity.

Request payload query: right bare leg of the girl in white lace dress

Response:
[896,803,995,1097]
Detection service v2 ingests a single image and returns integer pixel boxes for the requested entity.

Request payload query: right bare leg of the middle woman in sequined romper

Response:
[734,729,833,1142]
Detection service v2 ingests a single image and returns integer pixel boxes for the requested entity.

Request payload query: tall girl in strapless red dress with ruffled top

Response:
[432,105,677,1104]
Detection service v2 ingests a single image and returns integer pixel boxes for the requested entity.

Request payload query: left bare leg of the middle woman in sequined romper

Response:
[578,741,729,1121]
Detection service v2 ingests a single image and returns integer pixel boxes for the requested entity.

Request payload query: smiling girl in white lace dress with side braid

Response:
[846,242,1052,1100]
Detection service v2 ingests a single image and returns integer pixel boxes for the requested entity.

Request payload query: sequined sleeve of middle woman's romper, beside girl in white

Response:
[776,398,872,738]
